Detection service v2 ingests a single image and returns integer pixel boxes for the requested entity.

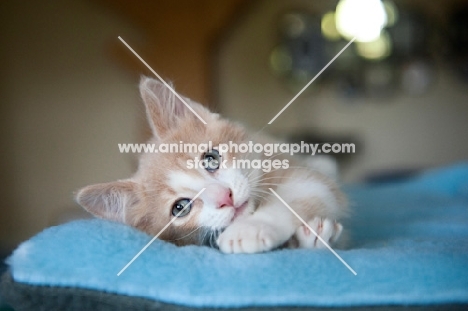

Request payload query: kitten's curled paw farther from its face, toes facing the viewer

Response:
[296,217,343,248]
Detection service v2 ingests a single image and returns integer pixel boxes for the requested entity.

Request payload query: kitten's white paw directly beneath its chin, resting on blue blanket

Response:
[217,222,283,253]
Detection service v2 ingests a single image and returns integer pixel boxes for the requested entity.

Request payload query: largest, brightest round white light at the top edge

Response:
[336,0,387,42]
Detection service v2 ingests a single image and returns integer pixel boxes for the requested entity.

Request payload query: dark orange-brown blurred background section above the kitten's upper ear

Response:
[94,0,252,105]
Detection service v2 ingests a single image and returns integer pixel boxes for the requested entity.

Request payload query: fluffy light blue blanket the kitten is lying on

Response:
[8,164,468,307]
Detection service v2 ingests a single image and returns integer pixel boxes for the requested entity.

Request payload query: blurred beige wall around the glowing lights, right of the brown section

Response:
[218,0,468,181]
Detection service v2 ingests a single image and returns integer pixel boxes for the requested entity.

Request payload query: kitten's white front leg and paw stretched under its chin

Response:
[217,203,297,253]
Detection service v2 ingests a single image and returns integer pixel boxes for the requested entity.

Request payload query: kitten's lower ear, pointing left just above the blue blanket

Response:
[76,181,140,223]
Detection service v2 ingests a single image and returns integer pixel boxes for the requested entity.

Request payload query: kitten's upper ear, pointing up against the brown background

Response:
[140,77,207,137]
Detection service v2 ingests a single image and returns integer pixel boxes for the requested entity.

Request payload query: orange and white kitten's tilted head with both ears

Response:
[77,78,259,245]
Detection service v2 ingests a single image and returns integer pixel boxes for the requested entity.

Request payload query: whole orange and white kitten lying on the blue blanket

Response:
[77,78,346,253]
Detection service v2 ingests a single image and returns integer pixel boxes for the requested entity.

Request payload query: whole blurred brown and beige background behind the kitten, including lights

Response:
[0,0,468,254]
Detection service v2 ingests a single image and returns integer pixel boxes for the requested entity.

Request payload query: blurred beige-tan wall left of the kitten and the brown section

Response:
[0,0,145,250]
